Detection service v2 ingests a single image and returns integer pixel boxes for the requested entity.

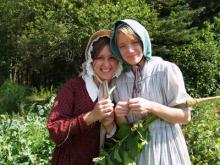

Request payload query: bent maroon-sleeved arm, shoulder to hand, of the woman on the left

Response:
[47,81,113,145]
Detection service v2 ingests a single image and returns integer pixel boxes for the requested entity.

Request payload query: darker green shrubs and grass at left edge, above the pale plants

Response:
[0,80,56,116]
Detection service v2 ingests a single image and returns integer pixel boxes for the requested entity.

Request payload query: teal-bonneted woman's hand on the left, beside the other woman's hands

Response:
[115,101,129,117]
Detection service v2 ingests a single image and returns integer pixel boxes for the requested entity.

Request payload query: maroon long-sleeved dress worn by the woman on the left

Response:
[47,77,100,165]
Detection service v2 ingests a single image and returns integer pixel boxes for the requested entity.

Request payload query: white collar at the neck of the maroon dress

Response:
[82,74,99,102]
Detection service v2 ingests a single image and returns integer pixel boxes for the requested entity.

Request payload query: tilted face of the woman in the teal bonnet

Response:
[116,31,143,65]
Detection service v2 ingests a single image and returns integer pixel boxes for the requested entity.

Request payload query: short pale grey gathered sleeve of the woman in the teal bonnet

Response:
[163,63,191,110]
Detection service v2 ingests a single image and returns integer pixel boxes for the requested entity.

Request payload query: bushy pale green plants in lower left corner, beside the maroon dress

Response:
[0,98,54,165]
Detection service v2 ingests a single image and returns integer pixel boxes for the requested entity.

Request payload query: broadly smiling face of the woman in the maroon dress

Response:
[92,44,118,81]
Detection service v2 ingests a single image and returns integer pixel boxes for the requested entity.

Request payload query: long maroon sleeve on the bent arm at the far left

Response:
[47,80,93,146]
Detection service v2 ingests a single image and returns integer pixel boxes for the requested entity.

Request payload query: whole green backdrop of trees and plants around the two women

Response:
[0,0,220,164]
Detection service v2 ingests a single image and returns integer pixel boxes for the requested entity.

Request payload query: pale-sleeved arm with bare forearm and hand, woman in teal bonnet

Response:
[129,63,191,124]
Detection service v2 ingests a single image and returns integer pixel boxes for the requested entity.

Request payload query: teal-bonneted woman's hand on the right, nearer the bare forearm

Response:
[128,97,153,115]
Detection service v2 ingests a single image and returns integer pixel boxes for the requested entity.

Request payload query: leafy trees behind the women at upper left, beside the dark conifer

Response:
[0,0,156,87]
